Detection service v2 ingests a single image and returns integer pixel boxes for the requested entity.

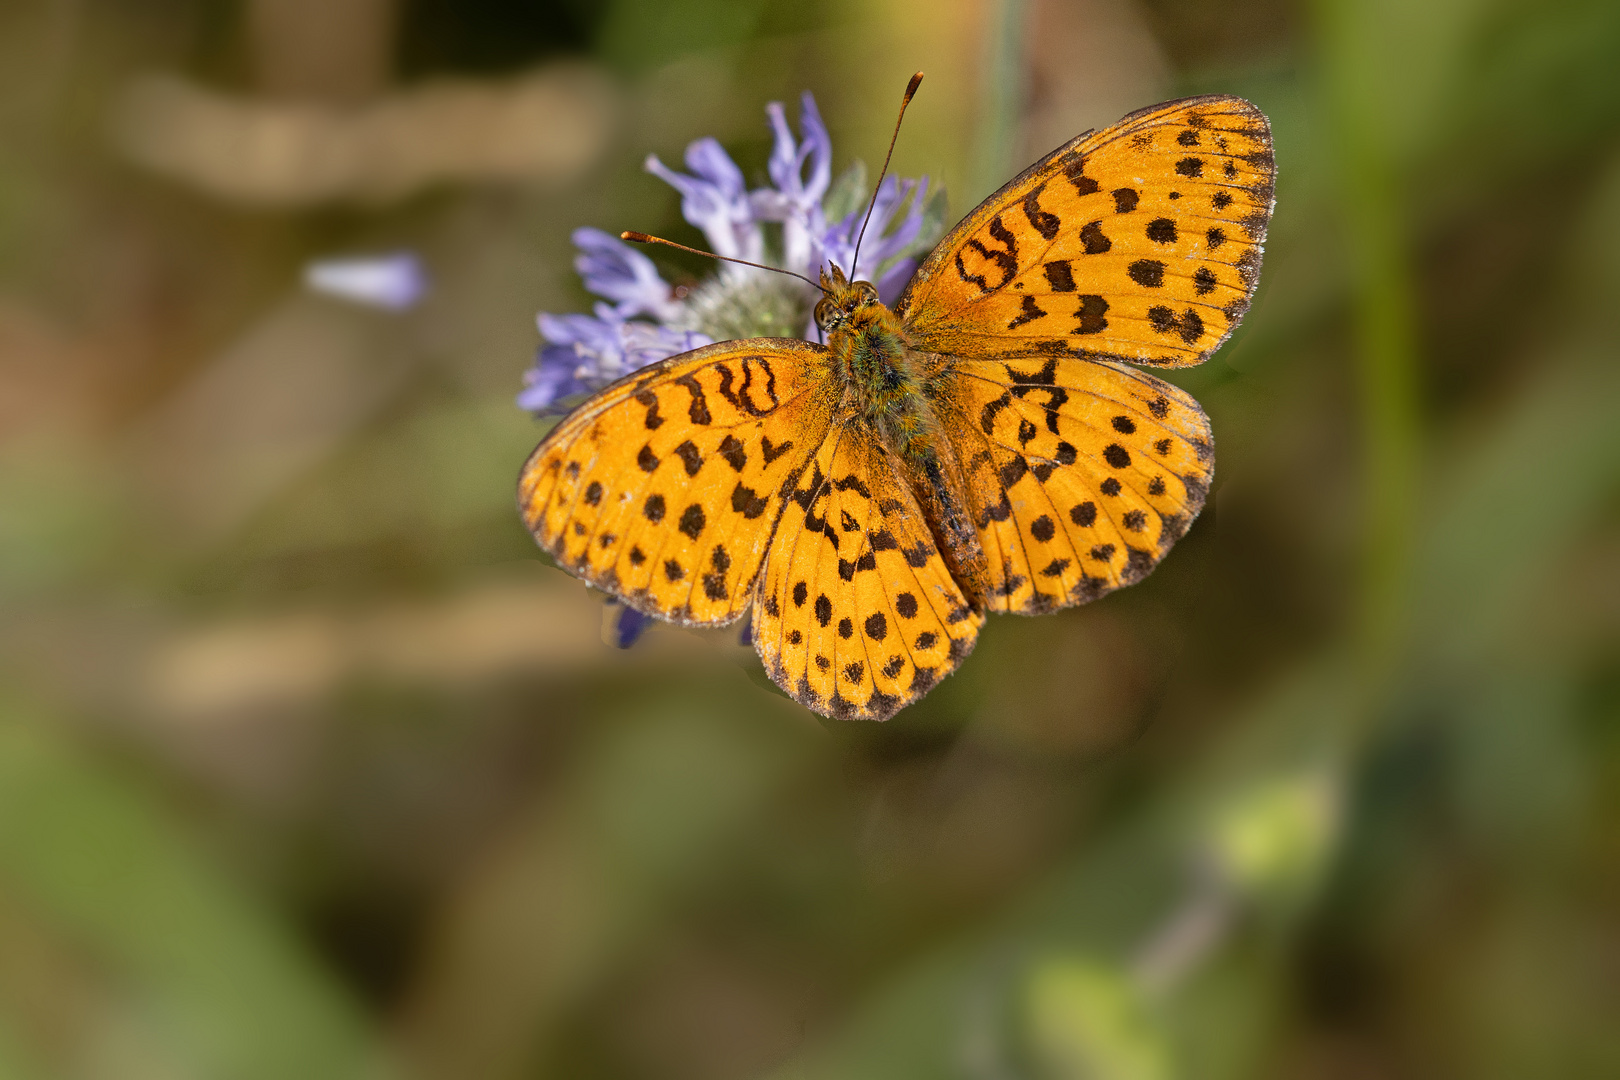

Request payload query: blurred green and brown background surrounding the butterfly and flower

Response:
[0,0,1620,1080]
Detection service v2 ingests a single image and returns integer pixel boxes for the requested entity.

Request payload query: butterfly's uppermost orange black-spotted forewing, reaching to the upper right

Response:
[894,96,1275,368]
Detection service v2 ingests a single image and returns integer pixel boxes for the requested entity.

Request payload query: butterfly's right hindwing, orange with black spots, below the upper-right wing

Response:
[948,356,1213,614]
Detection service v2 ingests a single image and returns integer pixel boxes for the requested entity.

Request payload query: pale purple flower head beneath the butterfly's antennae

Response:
[517,94,943,415]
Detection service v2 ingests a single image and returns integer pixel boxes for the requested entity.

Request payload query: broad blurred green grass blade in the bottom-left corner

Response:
[0,706,379,1080]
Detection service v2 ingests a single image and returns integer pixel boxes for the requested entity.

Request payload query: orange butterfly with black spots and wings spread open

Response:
[518,88,1275,721]
